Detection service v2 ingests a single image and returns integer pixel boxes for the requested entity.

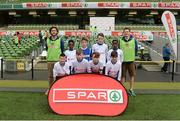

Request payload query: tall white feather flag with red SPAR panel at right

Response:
[161,11,177,58]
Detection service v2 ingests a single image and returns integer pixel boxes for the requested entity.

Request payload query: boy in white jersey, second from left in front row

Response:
[71,49,88,74]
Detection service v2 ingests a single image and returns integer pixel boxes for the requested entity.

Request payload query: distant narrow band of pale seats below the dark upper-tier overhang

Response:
[4,24,180,31]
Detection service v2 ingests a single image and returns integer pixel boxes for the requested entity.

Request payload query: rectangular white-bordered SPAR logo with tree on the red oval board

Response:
[53,88,123,103]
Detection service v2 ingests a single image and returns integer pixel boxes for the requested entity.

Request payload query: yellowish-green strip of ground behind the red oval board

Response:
[0,80,180,89]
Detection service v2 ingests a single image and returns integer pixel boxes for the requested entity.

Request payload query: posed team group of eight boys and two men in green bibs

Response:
[46,27,137,96]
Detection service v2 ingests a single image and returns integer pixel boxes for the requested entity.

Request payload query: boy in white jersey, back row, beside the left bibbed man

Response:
[64,40,76,66]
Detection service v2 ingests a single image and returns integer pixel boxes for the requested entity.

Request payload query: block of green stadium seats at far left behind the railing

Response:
[0,36,39,59]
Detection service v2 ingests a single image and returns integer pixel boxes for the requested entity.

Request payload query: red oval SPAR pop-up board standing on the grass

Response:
[48,74,128,116]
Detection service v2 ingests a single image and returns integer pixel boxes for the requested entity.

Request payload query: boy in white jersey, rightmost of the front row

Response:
[105,51,121,81]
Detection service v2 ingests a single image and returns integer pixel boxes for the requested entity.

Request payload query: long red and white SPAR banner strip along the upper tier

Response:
[0,2,180,9]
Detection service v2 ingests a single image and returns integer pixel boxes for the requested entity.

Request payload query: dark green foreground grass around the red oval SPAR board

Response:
[0,92,180,120]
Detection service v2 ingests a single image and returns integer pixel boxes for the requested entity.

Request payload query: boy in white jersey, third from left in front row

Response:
[88,52,104,74]
